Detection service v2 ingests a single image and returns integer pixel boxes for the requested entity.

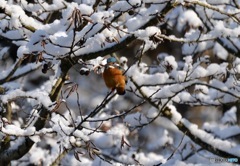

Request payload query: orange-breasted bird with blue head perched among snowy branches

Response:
[102,57,127,95]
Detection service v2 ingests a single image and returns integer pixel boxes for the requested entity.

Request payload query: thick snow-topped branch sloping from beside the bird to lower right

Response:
[131,75,240,163]
